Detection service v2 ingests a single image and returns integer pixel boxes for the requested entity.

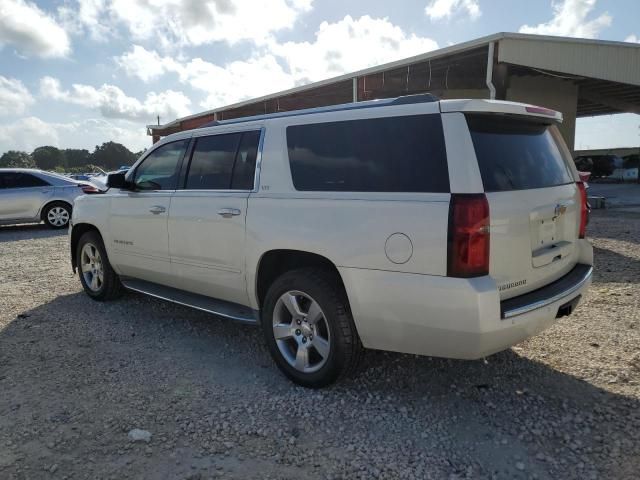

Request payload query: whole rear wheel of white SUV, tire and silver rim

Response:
[261,268,364,388]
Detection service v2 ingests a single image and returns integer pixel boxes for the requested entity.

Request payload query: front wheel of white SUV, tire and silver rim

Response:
[75,231,123,302]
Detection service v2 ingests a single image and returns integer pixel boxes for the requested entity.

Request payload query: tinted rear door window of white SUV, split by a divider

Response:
[185,131,260,190]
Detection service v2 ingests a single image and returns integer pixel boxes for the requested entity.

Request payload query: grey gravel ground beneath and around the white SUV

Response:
[0,211,640,479]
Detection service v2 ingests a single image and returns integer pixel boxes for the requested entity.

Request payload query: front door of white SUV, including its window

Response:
[108,139,189,285]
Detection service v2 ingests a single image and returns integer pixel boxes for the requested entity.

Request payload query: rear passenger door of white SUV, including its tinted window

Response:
[169,130,260,304]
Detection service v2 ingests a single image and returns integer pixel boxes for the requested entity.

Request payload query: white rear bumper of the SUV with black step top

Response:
[339,265,592,359]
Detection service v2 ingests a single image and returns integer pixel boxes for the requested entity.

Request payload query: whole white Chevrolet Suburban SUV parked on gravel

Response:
[69,95,593,387]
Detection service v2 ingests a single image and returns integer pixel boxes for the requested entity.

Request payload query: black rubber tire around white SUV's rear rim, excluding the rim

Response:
[261,271,346,388]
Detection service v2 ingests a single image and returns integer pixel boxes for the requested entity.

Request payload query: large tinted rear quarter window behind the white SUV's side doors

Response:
[287,115,449,192]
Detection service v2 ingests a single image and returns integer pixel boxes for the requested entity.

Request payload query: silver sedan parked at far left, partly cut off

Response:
[0,168,99,228]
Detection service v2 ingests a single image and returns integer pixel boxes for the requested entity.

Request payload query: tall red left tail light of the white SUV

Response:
[447,194,490,277]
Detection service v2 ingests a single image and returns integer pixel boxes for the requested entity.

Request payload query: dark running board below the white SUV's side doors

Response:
[120,277,258,323]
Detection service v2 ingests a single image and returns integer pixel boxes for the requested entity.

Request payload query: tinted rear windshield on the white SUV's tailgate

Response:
[467,115,574,192]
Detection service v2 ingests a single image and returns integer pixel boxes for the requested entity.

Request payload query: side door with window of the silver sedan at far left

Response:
[0,172,53,221]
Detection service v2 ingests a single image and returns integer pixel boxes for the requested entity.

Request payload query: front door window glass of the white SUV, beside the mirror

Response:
[133,139,189,190]
